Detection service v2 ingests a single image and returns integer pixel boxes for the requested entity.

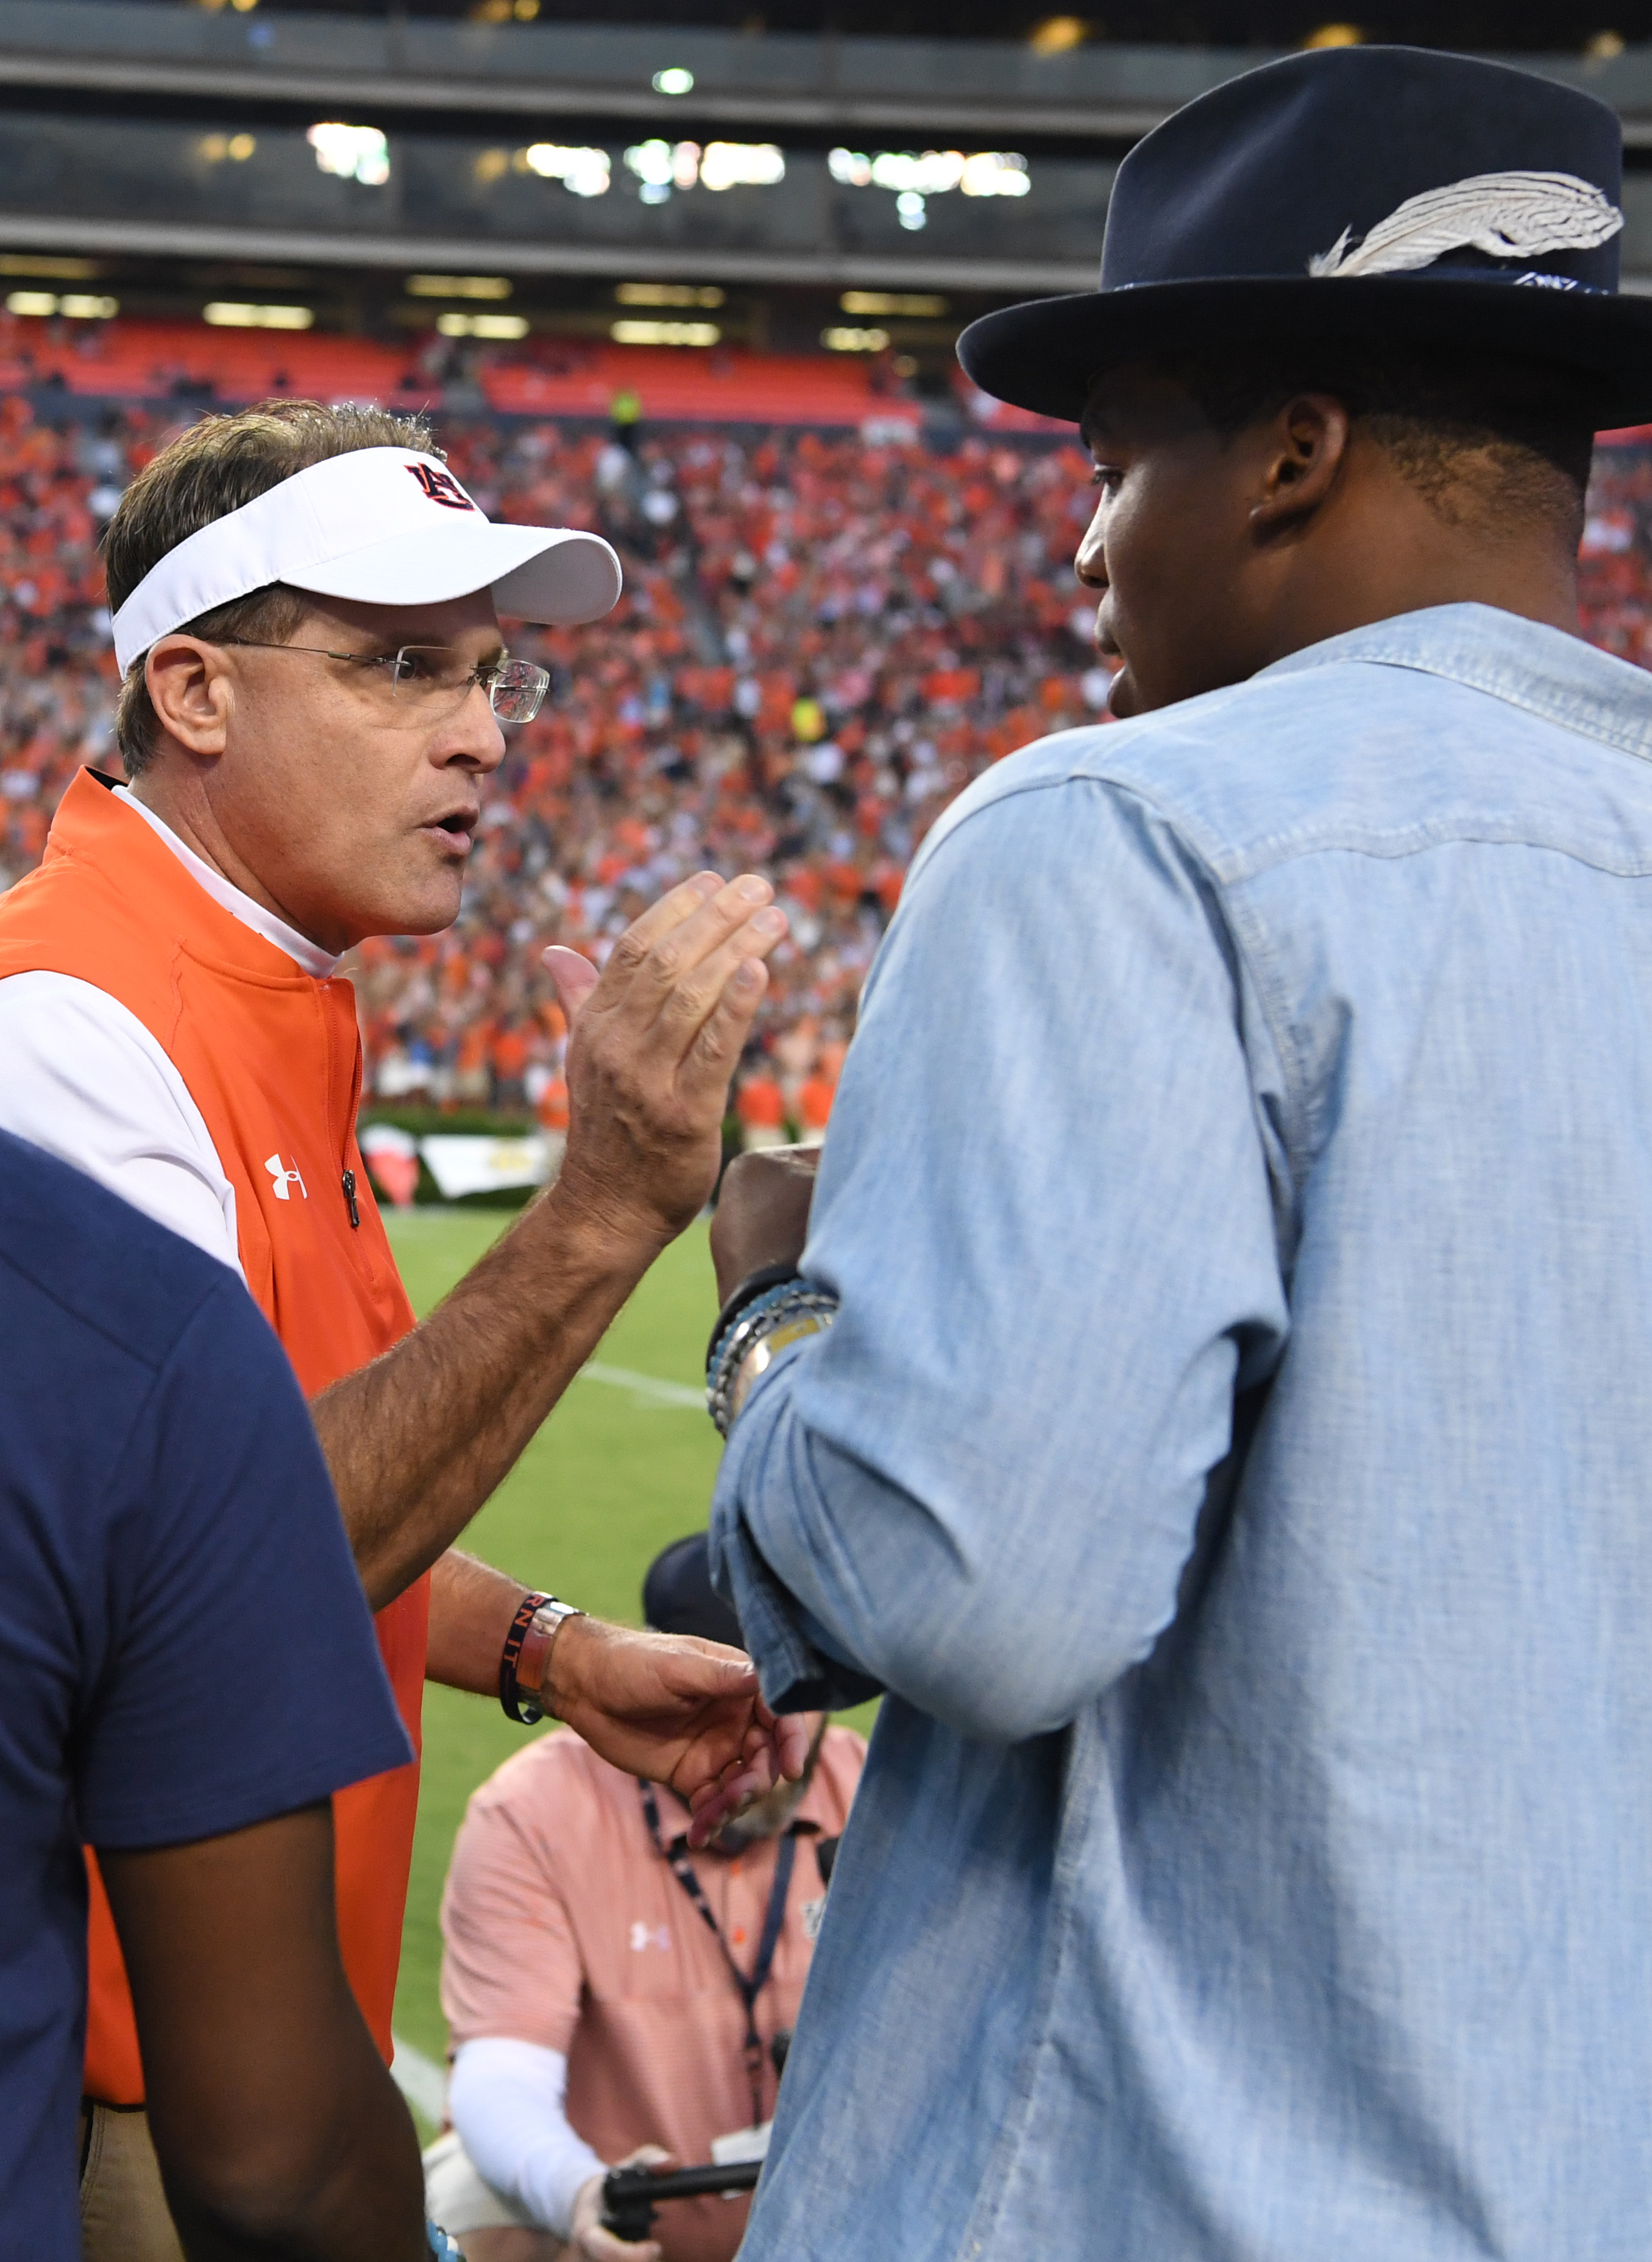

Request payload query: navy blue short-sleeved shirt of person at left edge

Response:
[0,1133,412,2262]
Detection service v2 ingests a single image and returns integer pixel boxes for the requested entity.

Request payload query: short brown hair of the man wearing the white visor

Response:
[104,400,441,778]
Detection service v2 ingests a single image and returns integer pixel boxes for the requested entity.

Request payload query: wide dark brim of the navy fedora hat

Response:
[957,276,1652,430]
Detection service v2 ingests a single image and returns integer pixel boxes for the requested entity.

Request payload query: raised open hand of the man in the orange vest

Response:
[545,873,785,1246]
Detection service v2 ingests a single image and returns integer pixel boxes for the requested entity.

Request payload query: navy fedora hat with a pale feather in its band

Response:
[957,48,1652,425]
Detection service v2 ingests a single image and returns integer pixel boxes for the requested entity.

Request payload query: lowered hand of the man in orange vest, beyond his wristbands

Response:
[545,1617,808,1846]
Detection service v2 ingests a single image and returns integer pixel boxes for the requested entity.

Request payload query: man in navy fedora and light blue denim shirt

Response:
[713,48,1652,2262]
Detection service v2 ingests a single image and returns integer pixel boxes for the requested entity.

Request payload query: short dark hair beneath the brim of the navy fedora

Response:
[1154,342,1595,543]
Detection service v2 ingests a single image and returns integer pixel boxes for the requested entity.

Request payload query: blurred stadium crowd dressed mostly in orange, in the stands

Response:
[0,394,1652,1144]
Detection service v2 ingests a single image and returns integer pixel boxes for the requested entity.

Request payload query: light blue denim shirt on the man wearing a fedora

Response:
[713,606,1652,2262]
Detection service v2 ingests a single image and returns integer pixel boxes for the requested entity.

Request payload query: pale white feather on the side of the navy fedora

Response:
[1308,172,1623,276]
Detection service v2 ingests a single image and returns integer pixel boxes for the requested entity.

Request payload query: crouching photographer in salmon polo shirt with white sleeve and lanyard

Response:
[425,1531,867,2262]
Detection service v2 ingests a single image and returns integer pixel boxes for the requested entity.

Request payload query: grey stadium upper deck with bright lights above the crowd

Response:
[0,0,1652,355]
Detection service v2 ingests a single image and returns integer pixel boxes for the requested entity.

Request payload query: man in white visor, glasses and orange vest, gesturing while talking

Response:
[0,403,803,2262]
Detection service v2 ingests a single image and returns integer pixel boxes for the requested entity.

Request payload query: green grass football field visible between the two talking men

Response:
[387,1210,871,2061]
